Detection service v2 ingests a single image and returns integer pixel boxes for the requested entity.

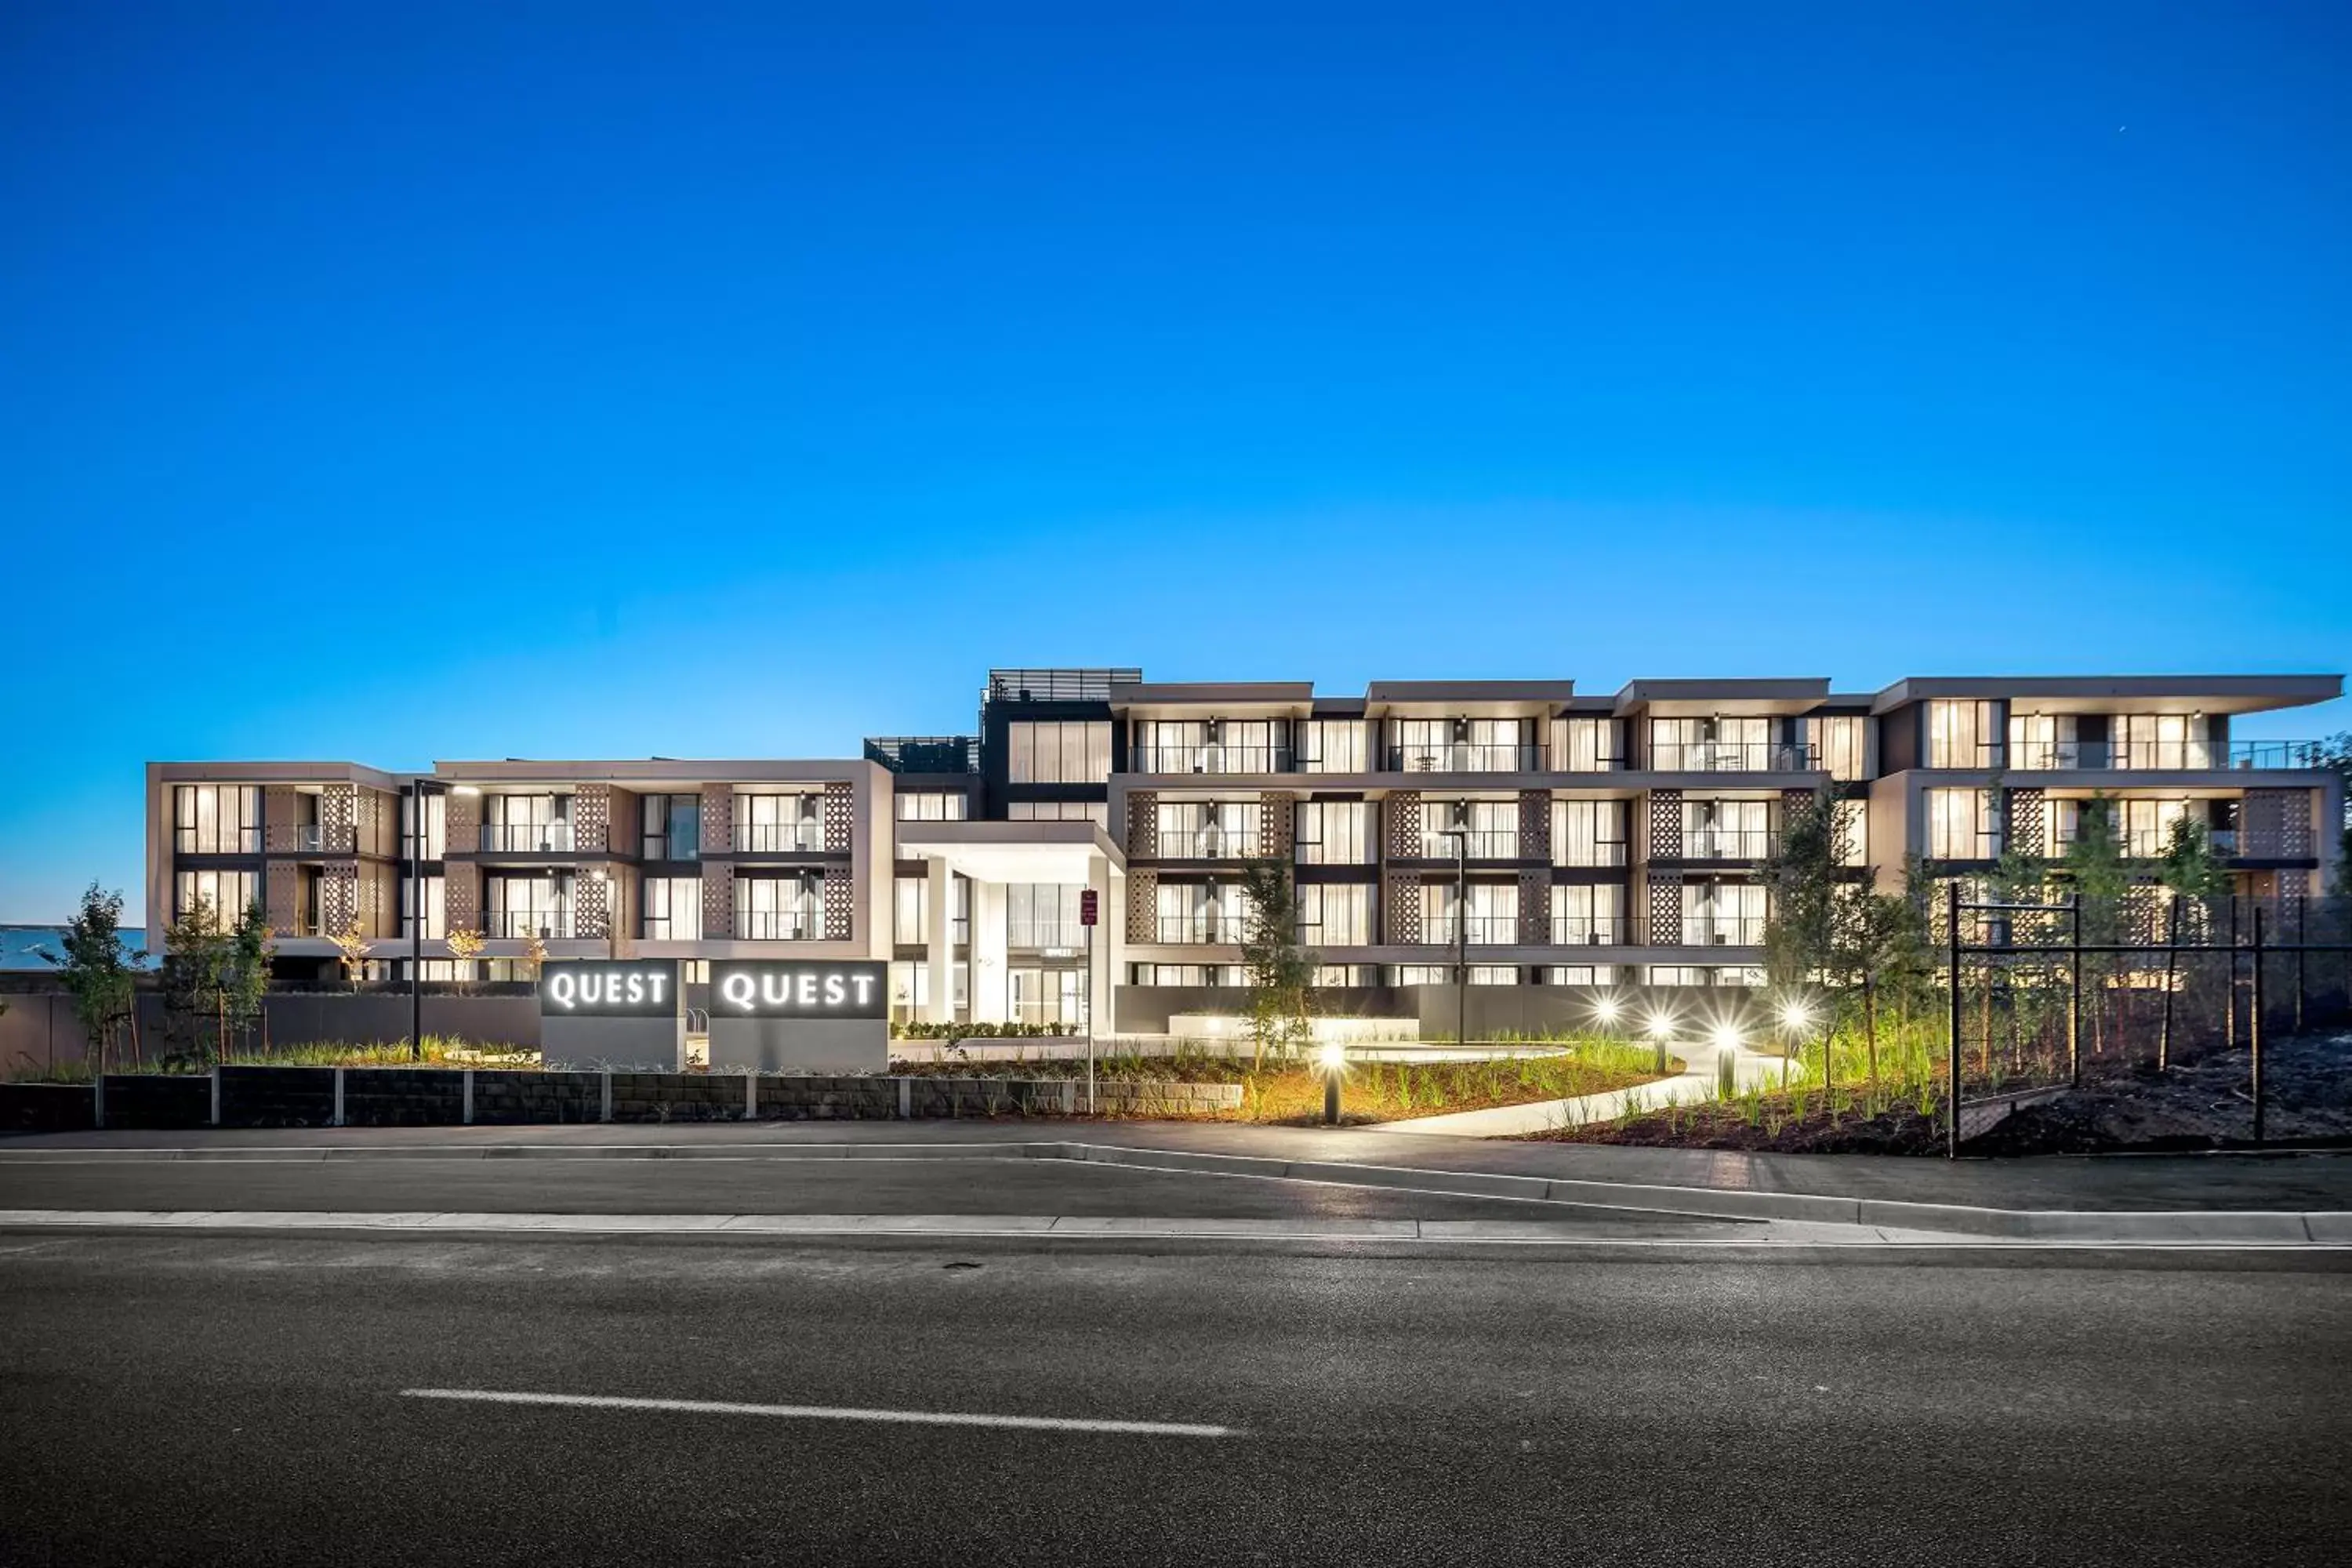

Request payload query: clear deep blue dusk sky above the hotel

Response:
[0,0,2352,919]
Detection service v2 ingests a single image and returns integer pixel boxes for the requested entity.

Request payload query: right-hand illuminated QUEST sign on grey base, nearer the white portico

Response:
[710,959,889,1072]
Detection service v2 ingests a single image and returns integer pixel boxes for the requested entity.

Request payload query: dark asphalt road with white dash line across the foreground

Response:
[0,1234,2352,1568]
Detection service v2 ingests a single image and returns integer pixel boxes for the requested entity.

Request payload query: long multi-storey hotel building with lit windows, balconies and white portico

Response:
[146,668,2343,1032]
